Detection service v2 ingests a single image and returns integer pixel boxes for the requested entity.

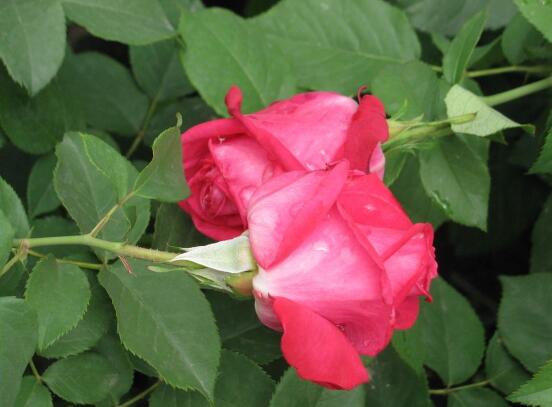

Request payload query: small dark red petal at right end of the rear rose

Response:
[344,95,389,172]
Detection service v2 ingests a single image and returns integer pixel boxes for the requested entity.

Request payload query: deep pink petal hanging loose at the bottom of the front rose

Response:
[274,298,369,390]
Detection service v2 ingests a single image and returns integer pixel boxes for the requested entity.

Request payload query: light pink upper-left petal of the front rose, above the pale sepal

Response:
[248,162,348,268]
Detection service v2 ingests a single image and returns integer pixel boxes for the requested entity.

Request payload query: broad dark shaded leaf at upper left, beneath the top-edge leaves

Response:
[63,51,148,135]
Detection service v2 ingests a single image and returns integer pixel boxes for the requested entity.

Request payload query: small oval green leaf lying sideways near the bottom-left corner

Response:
[42,352,117,404]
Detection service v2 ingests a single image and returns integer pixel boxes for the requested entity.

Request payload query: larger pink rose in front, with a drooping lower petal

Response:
[248,161,437,389]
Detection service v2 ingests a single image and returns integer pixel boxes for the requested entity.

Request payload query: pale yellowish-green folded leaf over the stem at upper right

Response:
[445,85,530,137]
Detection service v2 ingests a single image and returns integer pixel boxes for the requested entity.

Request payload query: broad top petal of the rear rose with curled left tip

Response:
[227,87,358,170]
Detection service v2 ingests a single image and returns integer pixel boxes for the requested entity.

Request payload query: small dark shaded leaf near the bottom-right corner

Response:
[485,332,529,394]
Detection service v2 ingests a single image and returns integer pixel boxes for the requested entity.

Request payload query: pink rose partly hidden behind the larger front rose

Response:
[180,87,388,240]
